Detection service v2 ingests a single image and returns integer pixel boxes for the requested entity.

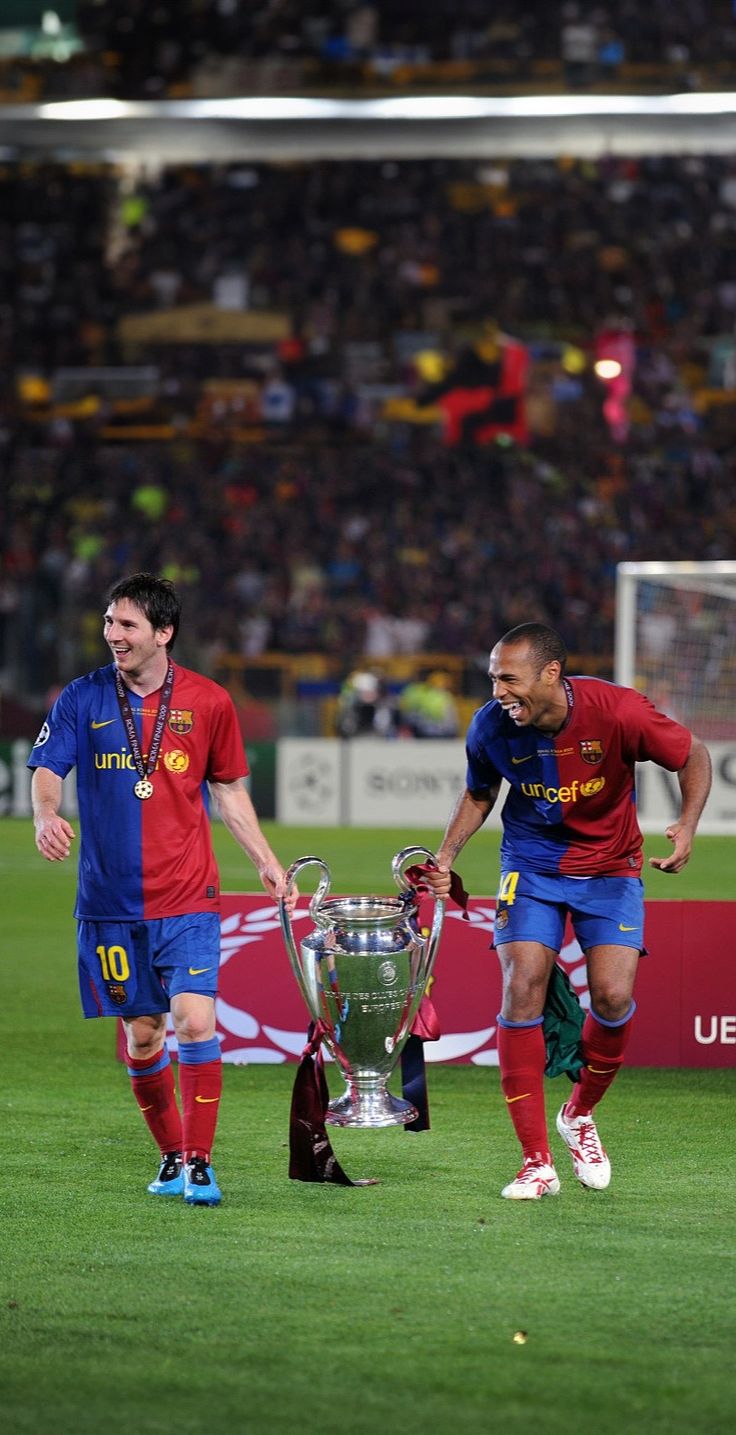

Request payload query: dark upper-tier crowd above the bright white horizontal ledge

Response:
[0,0,736,99]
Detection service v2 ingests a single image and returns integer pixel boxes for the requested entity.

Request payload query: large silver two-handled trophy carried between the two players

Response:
[278,847,445,1126]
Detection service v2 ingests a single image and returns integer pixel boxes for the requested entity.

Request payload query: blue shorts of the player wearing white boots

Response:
[494,872,644,951]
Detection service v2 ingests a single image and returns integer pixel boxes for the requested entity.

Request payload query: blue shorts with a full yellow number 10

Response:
[77,911,220,1020]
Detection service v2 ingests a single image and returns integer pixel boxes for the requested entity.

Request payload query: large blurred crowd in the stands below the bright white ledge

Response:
[0,156,736,711]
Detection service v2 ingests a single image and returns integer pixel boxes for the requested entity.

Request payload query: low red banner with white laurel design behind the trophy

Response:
[121,893,736,1066]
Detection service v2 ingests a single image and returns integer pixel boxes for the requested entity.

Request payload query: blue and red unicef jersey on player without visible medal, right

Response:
[466,677,692,877]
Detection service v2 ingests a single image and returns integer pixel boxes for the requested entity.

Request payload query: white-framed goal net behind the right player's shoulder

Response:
[615,561,736,742]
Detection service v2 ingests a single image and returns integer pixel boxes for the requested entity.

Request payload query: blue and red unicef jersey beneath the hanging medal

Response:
[29,663,248,921]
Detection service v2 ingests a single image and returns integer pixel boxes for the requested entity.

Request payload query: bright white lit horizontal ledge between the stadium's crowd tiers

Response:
[0,92,736,162]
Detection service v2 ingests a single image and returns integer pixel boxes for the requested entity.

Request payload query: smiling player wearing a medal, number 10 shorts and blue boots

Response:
[29,573,292,1205]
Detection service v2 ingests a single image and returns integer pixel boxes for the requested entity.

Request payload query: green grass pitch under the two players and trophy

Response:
[0,819,736,1435]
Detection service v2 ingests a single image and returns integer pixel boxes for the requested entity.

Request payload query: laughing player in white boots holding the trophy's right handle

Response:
[428,623,710,1201]
